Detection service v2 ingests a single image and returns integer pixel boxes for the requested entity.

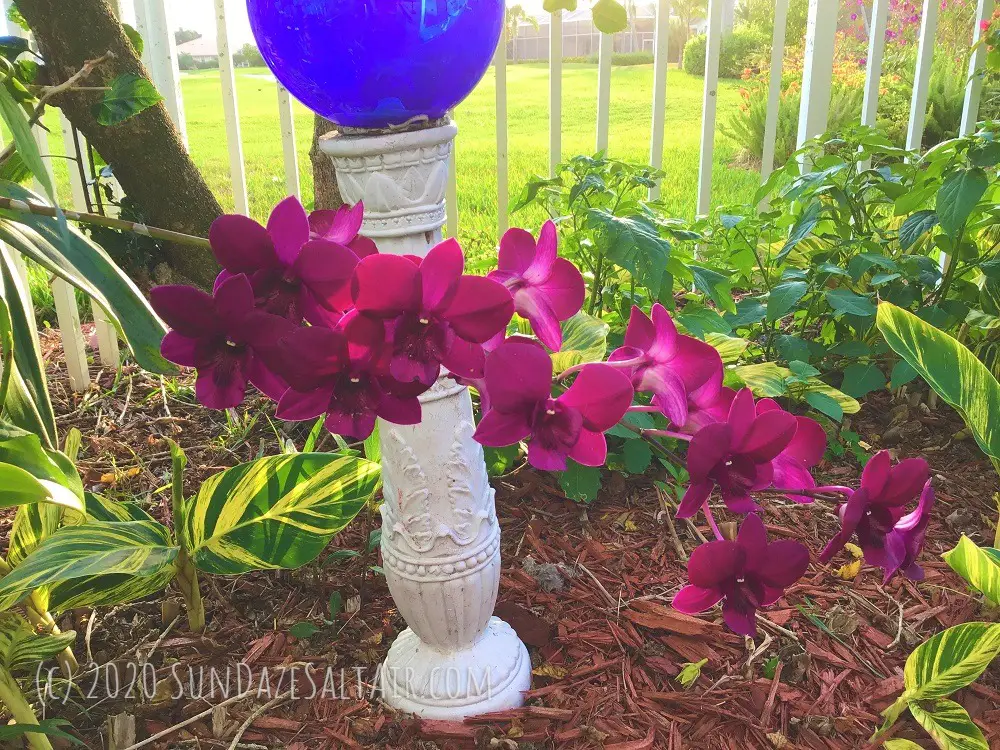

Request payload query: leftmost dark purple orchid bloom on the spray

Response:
[149,274,288,409]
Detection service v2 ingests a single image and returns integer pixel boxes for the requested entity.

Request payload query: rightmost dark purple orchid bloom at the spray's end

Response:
[820,451,930,570]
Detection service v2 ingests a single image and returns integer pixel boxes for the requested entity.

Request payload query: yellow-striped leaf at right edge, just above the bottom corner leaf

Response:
[903,622,1000,709]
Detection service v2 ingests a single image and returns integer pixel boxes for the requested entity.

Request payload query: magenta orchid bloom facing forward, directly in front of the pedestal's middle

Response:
[353,239,514,386]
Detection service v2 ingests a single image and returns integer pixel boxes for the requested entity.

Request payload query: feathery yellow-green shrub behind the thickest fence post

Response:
[721,84,862,166]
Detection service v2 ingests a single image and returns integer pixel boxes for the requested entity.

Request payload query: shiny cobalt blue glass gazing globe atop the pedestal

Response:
[247,0,504,128]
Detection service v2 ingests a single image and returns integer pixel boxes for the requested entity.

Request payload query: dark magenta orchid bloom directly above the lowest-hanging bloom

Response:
[677,388,798,518]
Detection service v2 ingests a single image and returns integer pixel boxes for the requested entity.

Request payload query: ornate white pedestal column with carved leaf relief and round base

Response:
[320,123,531,719]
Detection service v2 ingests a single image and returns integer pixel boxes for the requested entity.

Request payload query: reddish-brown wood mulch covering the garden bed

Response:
[9,330,1000,750]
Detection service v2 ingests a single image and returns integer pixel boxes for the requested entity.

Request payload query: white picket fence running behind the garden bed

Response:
[4,0,994,390]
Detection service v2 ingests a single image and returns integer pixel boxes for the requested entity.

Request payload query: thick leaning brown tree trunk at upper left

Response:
[17,0,222,286]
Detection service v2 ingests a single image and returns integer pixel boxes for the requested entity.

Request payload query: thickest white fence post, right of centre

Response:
[795,0,839,153]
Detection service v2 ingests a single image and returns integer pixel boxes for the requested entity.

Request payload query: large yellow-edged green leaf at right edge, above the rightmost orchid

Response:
[877,302,1000,458]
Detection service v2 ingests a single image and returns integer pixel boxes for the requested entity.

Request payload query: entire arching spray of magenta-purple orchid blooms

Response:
[152,198,934,635]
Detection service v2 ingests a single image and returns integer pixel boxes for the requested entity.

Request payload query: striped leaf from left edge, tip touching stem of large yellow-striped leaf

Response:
[0,521,177,609]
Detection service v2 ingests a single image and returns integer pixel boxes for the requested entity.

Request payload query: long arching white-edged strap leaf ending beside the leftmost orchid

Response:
[0,182,176,373]
